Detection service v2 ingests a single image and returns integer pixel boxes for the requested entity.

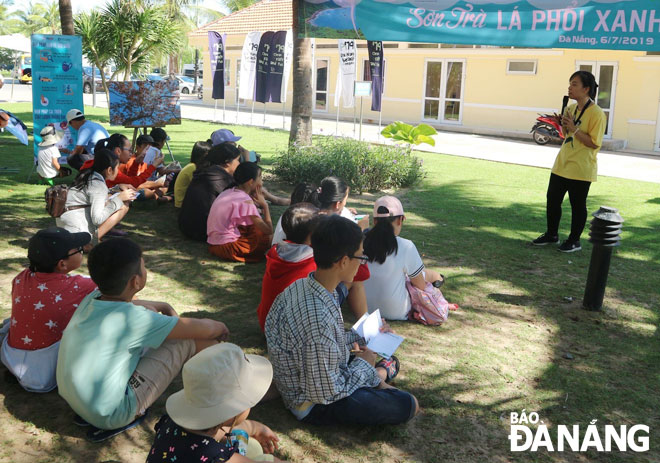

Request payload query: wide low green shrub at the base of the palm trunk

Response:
[274,137,425,193]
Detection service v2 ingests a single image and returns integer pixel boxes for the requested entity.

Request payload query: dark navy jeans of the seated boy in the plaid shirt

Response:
[302,387,415,425]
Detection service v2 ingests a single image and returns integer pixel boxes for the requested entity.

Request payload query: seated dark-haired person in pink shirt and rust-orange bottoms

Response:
[206,162,273,262]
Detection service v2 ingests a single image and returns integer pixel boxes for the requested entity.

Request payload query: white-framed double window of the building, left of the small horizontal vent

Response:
[423,60,465,122]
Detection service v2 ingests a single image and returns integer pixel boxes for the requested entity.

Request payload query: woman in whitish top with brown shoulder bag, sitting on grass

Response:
[55,149,135,240]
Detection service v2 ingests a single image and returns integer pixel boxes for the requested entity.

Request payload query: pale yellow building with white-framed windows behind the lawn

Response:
[189,0,660,155]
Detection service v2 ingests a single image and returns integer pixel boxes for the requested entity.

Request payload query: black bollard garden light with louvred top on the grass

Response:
[582,206,623,310]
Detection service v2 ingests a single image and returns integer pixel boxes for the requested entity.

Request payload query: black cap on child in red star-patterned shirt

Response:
[28,227,92,267]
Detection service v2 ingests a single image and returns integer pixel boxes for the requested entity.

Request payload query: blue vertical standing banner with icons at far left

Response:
[32,34,84,156]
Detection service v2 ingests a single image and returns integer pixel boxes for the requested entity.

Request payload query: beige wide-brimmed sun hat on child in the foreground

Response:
[165,343,273,430]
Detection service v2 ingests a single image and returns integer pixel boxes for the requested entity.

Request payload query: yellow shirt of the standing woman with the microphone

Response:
[552,103,607,182]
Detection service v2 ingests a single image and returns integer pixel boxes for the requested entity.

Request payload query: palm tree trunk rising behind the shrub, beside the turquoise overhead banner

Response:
[289,0,313,145]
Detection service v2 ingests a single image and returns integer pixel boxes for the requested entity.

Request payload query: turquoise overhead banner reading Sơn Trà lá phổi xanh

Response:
[297,0,660,51]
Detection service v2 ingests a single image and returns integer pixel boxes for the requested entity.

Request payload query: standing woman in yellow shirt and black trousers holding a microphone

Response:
[532,71,607,252]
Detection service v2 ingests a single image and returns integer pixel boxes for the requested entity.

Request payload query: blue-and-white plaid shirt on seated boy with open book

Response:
[265,273,380,409]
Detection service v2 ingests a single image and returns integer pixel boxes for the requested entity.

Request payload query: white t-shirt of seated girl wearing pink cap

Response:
[364,236,424,320]
